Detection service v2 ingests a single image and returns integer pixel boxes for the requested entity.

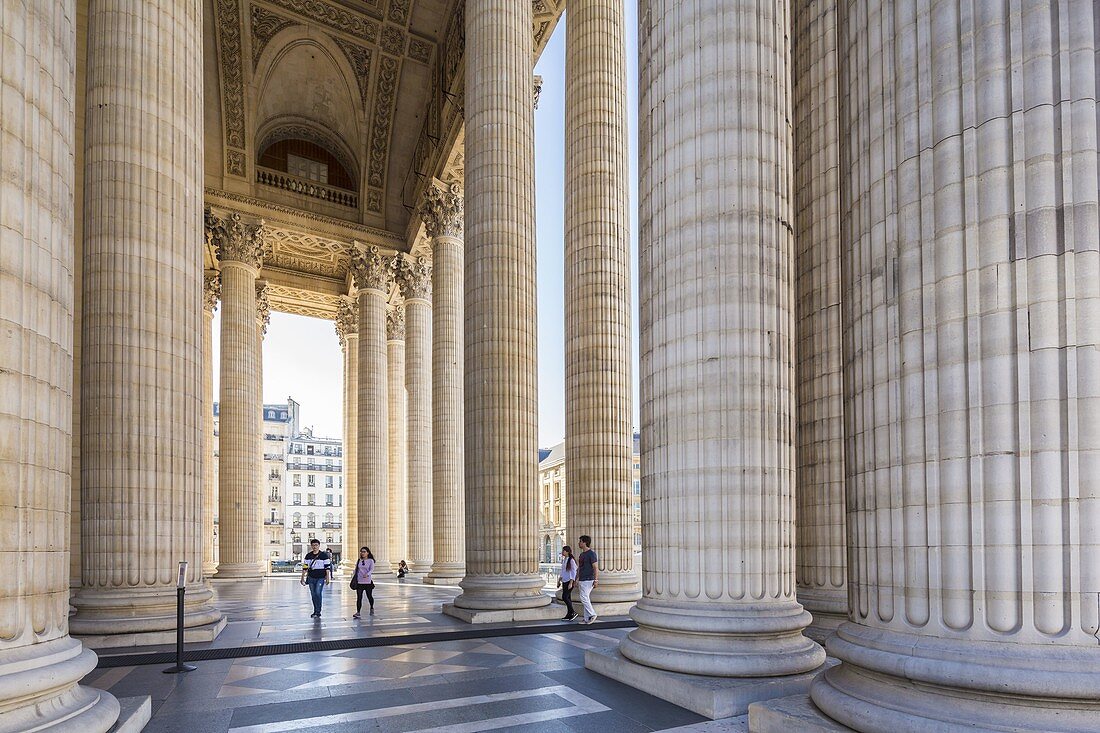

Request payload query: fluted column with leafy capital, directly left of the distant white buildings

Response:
[208,214,263,580]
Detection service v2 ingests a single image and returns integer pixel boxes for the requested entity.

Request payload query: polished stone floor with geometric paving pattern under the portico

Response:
[85,579,744,733]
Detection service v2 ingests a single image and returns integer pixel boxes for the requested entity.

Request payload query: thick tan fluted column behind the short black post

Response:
[69,0,226,647]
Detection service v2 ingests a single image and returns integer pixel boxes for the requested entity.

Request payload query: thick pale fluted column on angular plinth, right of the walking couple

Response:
[585,0,825,718]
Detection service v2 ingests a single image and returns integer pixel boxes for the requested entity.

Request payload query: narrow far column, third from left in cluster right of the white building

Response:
[386,302,409,570]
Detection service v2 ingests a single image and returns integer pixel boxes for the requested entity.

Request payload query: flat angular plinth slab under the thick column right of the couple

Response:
[584,647,824,717]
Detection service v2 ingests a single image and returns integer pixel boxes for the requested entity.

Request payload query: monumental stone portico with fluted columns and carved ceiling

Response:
[0,0,1100,733]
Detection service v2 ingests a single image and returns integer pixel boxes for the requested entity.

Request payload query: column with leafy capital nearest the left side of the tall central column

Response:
[420,182,466,586]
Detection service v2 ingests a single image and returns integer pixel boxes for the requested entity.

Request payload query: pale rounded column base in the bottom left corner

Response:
[0,636,119,733]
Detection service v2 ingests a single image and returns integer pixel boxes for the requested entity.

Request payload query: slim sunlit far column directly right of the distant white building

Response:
[336,296,362,570]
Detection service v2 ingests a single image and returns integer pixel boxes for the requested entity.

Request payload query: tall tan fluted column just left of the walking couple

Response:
[443,0,556,621]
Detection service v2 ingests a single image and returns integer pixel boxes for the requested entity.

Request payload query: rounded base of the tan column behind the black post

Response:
[69,582,226,649]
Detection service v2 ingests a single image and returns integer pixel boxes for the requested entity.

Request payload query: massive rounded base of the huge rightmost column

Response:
[810,623,1100,733]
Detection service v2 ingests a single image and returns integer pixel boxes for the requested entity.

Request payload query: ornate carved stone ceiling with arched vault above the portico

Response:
[206,0,565,318]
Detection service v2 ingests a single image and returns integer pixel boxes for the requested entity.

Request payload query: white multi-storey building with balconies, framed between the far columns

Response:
[284,427,344,562]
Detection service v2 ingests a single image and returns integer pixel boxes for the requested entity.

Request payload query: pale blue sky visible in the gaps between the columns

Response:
[215,5,638,447]
